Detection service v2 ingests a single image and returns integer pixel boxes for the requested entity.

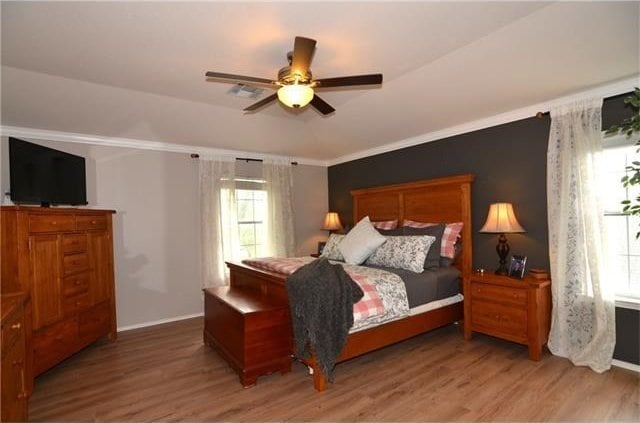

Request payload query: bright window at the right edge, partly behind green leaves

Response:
[603,138,640,300]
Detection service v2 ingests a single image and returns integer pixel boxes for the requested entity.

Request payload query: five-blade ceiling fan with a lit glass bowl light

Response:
[205,37,382,115]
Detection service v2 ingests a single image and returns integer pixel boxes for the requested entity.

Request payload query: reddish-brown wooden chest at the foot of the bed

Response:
[204,286,292,387]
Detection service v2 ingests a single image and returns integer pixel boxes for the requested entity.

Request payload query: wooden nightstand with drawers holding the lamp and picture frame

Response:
[464,273,551,361]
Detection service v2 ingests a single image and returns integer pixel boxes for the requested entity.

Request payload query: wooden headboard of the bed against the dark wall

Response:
[351,175,474,276]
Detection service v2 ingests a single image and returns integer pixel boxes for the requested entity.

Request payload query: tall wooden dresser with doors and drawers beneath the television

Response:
[1,206,116,377]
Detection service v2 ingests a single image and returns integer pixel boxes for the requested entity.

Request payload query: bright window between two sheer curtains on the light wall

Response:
[236,189,267,259]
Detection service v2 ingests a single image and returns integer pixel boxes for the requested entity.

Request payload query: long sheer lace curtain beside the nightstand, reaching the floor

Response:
[547,99,615,372]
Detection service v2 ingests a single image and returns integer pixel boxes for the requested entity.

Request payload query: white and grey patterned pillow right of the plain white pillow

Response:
[366,235,435,273]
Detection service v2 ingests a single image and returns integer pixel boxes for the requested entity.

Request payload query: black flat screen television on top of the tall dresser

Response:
[9,138,87,207]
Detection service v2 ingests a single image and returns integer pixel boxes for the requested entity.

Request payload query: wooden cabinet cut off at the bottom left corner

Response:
[2,293,28,422]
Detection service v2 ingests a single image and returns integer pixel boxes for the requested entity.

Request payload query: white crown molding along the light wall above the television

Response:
[0,125,327,167]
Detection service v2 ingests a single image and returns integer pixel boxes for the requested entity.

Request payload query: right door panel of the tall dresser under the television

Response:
[89,232,113,304]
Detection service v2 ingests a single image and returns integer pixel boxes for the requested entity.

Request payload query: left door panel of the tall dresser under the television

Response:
[29,235,62,330]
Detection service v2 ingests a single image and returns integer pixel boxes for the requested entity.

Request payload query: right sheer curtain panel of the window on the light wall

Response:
[262,159,295,257]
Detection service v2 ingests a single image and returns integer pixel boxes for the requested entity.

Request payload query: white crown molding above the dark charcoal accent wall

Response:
[327,74,640,166]
